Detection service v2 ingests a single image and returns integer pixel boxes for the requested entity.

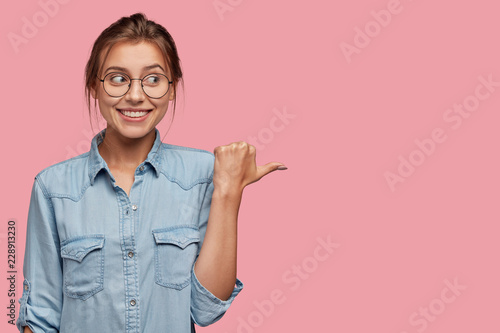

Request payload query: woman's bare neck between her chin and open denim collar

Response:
[97,127,156,170]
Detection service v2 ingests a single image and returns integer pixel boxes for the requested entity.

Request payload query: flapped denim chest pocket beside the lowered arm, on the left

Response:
[61,235,104,300]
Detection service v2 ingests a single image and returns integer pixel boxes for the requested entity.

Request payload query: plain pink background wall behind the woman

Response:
[0,0,500,333]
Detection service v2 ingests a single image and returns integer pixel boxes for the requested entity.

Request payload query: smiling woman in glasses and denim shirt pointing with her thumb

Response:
[17,13,286,333]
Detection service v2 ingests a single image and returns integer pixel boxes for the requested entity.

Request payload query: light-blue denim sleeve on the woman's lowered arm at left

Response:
[16,176,63,333]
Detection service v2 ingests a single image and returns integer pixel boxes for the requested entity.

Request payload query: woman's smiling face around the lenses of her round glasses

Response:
[91,42,175,139]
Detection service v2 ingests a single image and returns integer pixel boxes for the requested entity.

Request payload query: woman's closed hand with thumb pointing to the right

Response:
[214,141,287,193]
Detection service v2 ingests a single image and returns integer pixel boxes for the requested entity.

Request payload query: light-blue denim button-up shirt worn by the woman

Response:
[17,128,243,333]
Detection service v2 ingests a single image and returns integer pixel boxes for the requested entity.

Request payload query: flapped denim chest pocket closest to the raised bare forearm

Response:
[153,226,200,290]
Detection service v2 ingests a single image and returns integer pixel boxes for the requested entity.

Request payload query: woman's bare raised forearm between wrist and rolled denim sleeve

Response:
[194,187,242,300]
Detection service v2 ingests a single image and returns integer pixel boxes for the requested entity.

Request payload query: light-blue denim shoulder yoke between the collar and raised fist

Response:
[156,143,215,189]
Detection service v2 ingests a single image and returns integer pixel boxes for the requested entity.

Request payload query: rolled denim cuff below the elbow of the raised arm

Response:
[191,266,243,327]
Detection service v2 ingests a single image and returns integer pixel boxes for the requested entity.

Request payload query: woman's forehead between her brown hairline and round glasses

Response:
[102,42,168,75]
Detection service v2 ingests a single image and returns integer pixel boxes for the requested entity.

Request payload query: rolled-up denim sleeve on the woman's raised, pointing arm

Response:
[191,178,243,327]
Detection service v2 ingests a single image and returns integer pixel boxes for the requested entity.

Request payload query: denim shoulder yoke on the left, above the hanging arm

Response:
[35,152,90,199]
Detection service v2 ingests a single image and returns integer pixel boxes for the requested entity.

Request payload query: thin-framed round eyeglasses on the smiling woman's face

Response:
[99,72,173,98]
